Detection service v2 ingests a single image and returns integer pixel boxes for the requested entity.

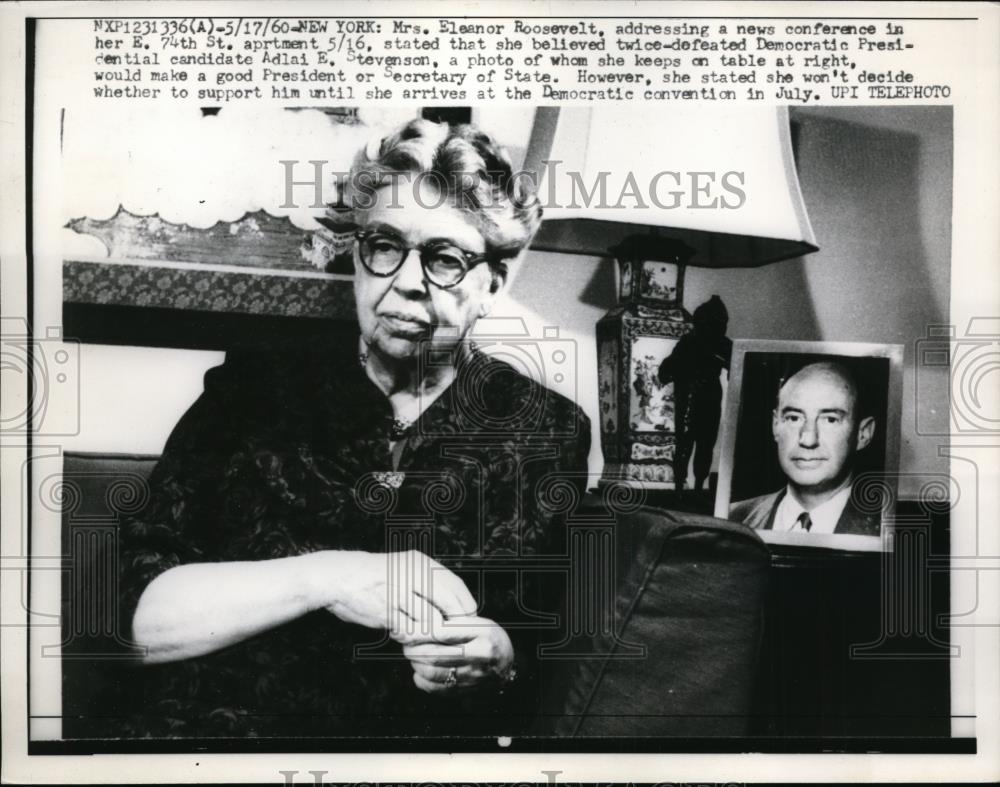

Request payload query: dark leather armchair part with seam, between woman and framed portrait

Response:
[537,508,770,738]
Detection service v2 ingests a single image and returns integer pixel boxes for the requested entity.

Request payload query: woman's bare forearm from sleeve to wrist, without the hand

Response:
[132,553,335,664]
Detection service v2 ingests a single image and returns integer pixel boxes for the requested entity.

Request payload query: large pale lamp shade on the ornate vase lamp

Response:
[525,105,817,268]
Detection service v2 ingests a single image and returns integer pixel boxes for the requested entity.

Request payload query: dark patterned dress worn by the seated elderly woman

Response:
[119,336,590,737]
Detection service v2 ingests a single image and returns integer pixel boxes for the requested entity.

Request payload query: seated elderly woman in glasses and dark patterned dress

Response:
[121,121,590,737]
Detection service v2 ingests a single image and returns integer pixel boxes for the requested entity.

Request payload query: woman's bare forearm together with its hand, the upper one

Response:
[132,550,476,664]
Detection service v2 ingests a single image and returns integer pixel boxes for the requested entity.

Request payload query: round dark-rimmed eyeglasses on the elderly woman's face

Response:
[354,230,491,290]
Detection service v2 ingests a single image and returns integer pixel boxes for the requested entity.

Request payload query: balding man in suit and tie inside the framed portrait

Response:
[729,362,880,536]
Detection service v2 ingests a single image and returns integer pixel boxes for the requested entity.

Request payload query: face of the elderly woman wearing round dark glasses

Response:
[354,179,502,360]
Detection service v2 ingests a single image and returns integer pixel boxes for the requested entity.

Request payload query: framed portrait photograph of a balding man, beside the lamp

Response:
[715,340,903,551]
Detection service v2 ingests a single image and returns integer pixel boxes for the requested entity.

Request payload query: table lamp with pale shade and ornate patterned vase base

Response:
[525,106,818,489]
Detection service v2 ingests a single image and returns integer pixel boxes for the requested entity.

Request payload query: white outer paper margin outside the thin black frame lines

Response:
[0,0,1000,784]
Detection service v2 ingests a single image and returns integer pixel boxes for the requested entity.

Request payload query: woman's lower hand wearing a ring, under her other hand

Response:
[403,615,514,694]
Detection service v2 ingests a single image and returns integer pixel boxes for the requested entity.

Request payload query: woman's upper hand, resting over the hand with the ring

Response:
[316,550,476,644]
